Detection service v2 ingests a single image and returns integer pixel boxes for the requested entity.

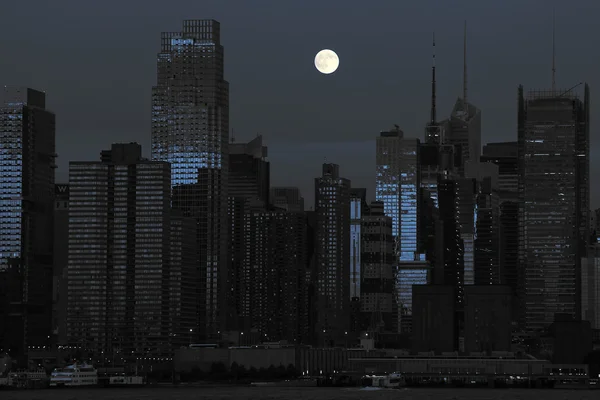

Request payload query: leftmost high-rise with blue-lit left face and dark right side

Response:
[0,87,56,366]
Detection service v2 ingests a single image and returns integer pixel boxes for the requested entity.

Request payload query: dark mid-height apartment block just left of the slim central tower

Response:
[239,201,306,343]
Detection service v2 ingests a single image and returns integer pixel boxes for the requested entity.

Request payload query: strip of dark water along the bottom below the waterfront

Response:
[0,387,600,400]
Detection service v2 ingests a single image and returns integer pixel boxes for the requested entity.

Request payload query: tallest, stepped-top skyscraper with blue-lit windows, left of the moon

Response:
[152,20,229,336]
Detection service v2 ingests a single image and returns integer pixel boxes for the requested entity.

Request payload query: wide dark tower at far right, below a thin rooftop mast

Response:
[518,84,590,330]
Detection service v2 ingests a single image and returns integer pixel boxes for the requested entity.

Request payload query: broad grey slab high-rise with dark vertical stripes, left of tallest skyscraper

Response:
[67,143,198,358]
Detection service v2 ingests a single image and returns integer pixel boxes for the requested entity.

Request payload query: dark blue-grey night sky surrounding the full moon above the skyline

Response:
[0,0,600,207]
